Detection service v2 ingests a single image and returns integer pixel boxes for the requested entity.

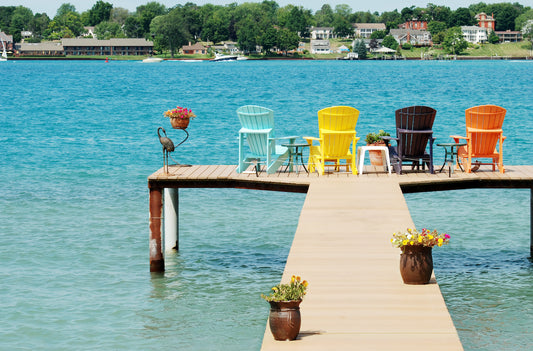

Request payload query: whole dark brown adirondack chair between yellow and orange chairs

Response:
[383,106,437,174]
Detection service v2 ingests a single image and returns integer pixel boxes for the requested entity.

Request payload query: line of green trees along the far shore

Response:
[0,0,533,54]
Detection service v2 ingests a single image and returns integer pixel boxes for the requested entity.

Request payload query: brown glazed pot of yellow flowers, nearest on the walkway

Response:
[261,275,308,340]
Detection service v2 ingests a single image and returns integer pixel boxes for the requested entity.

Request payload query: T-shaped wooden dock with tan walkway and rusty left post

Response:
[148,165,533,351]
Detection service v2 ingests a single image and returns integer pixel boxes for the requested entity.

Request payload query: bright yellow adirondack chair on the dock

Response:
[304,106,359,174]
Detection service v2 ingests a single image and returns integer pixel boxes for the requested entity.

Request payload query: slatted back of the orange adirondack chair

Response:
[465,105,507,157]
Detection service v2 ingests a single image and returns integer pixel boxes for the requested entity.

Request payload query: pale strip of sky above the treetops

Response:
[0,0,533,18]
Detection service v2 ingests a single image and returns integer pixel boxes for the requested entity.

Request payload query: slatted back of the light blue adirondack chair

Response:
[237,105,274,155]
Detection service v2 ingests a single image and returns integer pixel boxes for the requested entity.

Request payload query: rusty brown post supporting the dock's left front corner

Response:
[150,188,165,272]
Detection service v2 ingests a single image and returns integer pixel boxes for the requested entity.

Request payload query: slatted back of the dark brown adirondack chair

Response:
[396,106,437,157]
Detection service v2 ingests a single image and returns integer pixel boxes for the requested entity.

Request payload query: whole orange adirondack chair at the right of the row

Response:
[451,105,507,173]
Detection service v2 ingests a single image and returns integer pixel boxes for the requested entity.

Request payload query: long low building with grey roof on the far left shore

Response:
[61,38,154,56]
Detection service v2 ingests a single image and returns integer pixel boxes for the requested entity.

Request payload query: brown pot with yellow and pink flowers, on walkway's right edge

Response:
[391,228,450,284]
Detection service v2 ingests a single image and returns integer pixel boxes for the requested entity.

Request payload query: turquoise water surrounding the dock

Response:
[0,61,533,350]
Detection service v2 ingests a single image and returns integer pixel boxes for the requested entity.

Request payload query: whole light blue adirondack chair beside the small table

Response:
[237,105,296,174]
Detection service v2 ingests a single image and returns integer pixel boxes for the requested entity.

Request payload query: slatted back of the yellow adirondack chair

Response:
[318,106,359,158]
